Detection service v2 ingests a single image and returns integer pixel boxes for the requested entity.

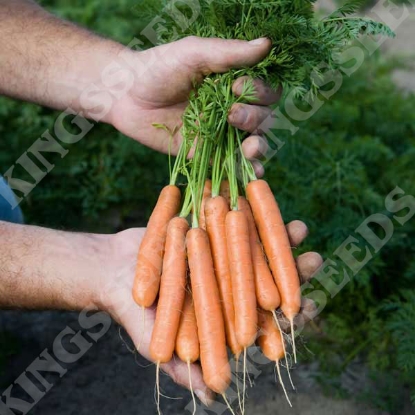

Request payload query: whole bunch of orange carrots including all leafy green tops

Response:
[127,0,400,410]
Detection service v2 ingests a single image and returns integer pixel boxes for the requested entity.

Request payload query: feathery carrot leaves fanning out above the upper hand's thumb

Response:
[151,0,393,96]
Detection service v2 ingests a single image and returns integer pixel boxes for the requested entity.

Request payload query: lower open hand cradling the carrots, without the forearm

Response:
[100,221,322,404]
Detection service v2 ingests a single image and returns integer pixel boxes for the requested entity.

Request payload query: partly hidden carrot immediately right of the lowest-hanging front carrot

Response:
[205,196,242,358]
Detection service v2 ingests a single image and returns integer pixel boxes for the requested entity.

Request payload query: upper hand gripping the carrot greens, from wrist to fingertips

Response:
[109,37,281,172]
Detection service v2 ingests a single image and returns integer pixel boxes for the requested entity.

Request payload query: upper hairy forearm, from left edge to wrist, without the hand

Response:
[0,0,124,117]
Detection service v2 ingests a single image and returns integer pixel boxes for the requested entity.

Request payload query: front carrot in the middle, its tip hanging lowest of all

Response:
[186,228,231,395]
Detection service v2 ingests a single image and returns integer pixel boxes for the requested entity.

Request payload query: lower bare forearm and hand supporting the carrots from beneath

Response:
[0,221,322,403]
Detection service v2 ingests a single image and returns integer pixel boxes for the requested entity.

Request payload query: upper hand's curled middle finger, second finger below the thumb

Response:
[228,104,272,133]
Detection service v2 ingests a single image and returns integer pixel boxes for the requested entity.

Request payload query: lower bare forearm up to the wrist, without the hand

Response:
[0,222,112,310]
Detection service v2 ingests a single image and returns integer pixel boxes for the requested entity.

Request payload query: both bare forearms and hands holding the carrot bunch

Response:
[0,0,322,410]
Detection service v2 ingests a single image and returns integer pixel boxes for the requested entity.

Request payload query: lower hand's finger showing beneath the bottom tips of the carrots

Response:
[160,357,215,406]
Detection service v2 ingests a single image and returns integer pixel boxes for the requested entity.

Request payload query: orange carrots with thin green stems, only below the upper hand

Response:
[133,79,301,412]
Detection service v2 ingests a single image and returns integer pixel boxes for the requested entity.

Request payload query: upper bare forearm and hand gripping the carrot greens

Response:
[0,0,281,167]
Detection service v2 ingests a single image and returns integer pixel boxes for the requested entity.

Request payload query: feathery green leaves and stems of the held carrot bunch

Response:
[162,0,394,227]
